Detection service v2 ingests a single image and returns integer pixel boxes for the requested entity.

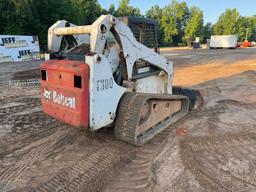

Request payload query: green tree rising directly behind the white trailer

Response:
[213,9,240,35]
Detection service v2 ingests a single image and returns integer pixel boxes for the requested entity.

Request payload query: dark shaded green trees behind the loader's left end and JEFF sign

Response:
[0,0,107,49]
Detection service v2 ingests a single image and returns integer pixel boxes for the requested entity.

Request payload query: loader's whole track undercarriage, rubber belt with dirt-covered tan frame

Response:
[115,93,189,146]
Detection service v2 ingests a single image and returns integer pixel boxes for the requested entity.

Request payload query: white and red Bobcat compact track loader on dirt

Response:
[41,15,202,146]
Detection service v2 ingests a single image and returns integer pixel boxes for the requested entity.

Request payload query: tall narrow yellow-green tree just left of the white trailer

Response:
[185,6,204,46]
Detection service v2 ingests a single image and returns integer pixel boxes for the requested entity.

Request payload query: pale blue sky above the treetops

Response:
[98,0,256,23]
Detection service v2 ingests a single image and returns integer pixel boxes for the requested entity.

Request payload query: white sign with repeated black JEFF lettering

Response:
[0,35,40,63]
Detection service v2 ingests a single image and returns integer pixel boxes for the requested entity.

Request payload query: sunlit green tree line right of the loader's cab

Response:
[146,0,256,46]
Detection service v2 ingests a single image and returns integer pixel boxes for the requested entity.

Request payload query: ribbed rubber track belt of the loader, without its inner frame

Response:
[115,93,188,146]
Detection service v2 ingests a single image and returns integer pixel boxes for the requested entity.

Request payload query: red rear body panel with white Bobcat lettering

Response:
[41,60,89,128]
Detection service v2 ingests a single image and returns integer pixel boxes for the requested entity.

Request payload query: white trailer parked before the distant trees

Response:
[210,35,238,49]
